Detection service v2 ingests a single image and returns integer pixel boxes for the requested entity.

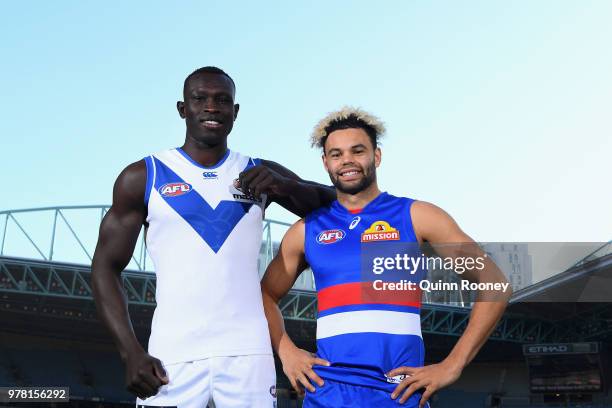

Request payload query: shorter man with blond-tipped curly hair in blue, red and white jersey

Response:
[262,108,510,408]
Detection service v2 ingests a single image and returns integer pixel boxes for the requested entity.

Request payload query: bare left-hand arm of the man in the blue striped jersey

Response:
[261,220,329,393]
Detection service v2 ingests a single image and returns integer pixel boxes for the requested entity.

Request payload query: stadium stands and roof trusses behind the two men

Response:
[0,206,612,408]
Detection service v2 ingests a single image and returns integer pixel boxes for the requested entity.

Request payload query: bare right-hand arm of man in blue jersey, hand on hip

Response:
[388,201,512,406]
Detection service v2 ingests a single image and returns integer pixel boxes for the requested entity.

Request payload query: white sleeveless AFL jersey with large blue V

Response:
[145,148,272,364]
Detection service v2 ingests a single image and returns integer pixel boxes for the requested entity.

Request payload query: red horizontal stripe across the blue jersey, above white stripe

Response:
[317,282,421,311]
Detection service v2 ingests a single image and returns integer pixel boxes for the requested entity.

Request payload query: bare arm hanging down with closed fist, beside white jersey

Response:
[91,160,168,398]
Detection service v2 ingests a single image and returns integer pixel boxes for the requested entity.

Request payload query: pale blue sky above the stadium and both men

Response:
[0,1,612,245]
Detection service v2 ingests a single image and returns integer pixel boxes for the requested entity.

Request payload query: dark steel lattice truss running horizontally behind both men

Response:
[0,257,612,343]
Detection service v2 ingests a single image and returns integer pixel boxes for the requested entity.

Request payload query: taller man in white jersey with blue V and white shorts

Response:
[92,67,334,408]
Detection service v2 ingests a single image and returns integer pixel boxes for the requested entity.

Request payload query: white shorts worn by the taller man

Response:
[136,354,276,408]
